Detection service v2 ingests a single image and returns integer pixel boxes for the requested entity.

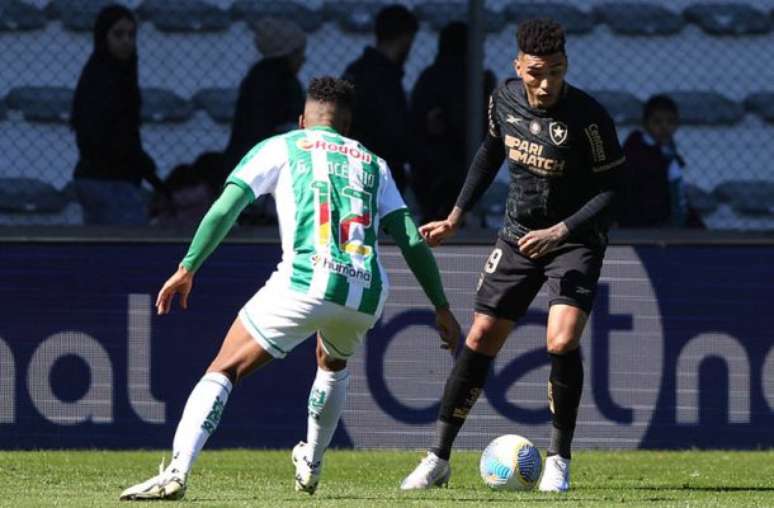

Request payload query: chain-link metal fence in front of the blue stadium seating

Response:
[0,0,774,230]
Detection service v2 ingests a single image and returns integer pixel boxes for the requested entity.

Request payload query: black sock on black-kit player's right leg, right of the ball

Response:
[548,348,583,459]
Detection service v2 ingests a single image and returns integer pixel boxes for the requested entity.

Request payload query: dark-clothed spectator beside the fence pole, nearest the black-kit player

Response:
[410,21,495,223]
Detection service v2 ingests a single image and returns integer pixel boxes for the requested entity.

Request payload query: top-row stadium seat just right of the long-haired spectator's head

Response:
[137,0,231,32]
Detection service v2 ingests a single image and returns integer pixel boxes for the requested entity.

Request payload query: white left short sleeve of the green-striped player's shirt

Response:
[226,136,287,199]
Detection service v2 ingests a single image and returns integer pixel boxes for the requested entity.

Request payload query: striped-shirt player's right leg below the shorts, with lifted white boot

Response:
[291,338,349,494]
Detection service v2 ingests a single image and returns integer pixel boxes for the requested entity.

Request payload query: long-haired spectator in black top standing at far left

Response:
[70,5,168,224]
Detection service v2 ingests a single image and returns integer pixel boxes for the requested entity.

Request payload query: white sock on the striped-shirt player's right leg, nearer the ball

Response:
[306,368,349,463]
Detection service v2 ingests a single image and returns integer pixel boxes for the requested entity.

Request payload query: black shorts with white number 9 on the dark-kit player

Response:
[475,238,605,321]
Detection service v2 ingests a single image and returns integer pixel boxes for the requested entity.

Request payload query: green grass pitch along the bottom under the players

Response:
[0,450,774,508]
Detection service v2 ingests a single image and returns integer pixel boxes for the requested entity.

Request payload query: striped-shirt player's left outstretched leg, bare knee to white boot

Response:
[120,320,271,501]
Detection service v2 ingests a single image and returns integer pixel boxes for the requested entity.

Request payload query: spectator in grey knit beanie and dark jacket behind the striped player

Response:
[223,17,306,175]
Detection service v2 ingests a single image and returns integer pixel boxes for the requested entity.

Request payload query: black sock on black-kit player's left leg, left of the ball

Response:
[430,346,494,460]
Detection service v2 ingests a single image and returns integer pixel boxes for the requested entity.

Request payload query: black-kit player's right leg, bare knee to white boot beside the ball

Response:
[538,306,586,492]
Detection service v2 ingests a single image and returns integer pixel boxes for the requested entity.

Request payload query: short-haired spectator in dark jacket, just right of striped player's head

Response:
[343,5,419,193]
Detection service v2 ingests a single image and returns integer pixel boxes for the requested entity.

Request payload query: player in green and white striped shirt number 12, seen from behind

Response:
[121,77,460,500]
